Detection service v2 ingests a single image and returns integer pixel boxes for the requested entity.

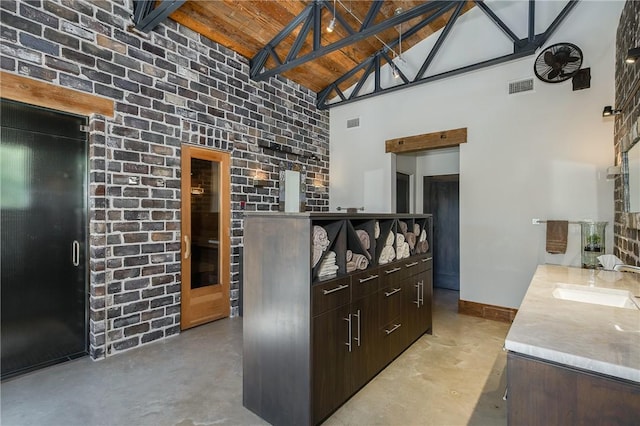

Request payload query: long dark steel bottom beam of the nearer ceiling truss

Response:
[250,0,457,81]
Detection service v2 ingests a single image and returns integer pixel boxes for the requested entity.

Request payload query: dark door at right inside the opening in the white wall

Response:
[423,174,460,290]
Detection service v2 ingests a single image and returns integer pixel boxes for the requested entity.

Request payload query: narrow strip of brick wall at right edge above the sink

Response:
[614,0,640,266]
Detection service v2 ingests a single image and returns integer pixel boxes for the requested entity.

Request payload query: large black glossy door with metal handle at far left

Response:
[0,100,87,378]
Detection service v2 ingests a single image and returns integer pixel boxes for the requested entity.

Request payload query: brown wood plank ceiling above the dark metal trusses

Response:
[169,0,474,92]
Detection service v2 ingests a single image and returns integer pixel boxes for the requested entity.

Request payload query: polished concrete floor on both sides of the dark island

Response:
[0,289,509,426]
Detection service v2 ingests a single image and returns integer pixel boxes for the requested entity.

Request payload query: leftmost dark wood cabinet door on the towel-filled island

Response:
[312,305,354,424]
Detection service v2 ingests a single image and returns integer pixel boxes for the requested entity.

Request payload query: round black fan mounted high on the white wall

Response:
[533,43,582,83]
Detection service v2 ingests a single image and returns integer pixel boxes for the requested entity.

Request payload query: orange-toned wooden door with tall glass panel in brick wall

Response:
[180,145,230,330]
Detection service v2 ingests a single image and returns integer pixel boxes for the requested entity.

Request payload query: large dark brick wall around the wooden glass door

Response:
[0,0,329,358]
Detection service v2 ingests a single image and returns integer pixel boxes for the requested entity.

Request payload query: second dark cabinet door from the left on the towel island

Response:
[351,293,385,392]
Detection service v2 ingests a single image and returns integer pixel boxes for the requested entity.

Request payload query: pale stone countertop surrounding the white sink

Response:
[505,265,640,382]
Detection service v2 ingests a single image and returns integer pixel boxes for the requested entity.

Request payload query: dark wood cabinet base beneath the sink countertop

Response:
[507,352,640,426]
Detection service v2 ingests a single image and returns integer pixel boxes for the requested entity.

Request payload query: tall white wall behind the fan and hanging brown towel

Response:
[330,1,624,307]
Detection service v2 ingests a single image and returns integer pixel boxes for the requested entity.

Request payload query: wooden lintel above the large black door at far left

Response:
[0,71,113,117]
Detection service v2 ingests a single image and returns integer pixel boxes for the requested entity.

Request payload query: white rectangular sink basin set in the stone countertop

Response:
[552,284,640,309]
